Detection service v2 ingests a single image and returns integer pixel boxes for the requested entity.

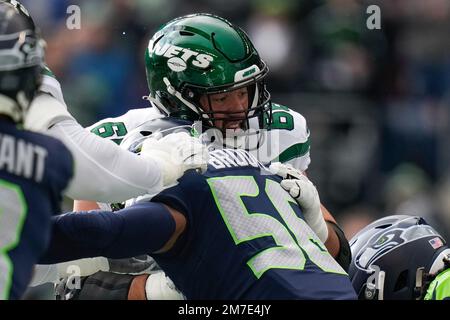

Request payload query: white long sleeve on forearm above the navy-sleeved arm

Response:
[47,118,162,202]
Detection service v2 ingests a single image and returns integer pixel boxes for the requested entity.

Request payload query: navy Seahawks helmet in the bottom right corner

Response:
[348,215,450,300]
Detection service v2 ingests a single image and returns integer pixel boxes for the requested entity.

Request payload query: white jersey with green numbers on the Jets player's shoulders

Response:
[87,103,311,171]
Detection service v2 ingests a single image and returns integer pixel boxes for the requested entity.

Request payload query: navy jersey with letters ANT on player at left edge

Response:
[0,121,73,299]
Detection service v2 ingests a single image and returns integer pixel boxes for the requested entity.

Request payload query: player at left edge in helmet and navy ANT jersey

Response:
[0,1,73,300]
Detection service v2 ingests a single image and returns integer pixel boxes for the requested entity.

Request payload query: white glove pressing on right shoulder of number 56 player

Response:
[269,162,328,242]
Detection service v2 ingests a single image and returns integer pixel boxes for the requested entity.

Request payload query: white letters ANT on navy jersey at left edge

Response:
[0,134,47,182]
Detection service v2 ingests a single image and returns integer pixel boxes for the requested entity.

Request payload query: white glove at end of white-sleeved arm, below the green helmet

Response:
[141,132,209,187]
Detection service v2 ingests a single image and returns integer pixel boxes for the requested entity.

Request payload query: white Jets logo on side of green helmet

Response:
[148,40,214,72]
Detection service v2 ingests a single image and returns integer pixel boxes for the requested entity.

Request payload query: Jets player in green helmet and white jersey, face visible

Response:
[74,14,350,268]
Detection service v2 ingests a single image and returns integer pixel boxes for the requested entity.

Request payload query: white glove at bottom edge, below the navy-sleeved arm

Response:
[145,271,186,300]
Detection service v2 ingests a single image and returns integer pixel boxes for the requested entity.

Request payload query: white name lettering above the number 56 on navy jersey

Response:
[208,149,261,169]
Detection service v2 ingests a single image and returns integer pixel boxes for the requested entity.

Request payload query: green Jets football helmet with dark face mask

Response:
[145,14,272,129]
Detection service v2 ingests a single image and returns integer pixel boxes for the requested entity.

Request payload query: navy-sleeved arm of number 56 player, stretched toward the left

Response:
[40,203,176,264]
